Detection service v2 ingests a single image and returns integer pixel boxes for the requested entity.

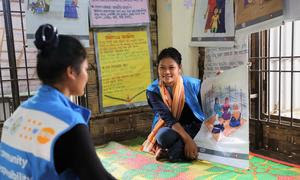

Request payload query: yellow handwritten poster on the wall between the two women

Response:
[97,31,151,108]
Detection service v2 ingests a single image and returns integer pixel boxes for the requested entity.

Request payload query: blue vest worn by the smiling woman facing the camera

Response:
[147,76,205,128]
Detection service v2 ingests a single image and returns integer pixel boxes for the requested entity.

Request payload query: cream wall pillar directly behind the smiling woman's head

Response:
[157,0,199,77]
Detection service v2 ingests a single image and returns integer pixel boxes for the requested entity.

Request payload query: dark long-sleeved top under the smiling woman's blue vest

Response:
[146,90,202,127]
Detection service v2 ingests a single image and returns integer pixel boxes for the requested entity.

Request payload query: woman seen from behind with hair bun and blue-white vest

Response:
[0,24,114,180]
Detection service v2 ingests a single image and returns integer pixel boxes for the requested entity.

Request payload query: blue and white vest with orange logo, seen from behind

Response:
[0,85,91,180]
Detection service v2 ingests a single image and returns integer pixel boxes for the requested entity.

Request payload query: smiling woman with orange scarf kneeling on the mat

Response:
[142,47,204,162]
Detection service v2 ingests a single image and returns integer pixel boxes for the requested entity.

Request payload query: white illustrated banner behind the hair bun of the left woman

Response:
[25,0,89,47]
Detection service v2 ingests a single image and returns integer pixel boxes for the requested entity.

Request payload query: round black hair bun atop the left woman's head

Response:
[34,24,58,50]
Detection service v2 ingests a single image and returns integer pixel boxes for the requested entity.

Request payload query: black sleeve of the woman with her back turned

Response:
[54,124,115,179]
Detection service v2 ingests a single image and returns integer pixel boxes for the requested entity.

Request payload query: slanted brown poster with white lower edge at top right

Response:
[235,0,283,34]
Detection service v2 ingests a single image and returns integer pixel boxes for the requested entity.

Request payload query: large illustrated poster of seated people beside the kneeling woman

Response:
[194,65,249,169]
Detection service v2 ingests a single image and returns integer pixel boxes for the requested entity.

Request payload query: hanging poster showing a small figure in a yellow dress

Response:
[191,0,234,47]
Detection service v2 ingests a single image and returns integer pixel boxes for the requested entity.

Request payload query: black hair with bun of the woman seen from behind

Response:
[34,24,86,85]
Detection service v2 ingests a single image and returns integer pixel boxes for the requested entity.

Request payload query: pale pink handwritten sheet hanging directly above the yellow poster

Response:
[90,0,149,27]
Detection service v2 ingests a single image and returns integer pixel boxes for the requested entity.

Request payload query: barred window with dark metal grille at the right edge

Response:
[250,21,300,127]
